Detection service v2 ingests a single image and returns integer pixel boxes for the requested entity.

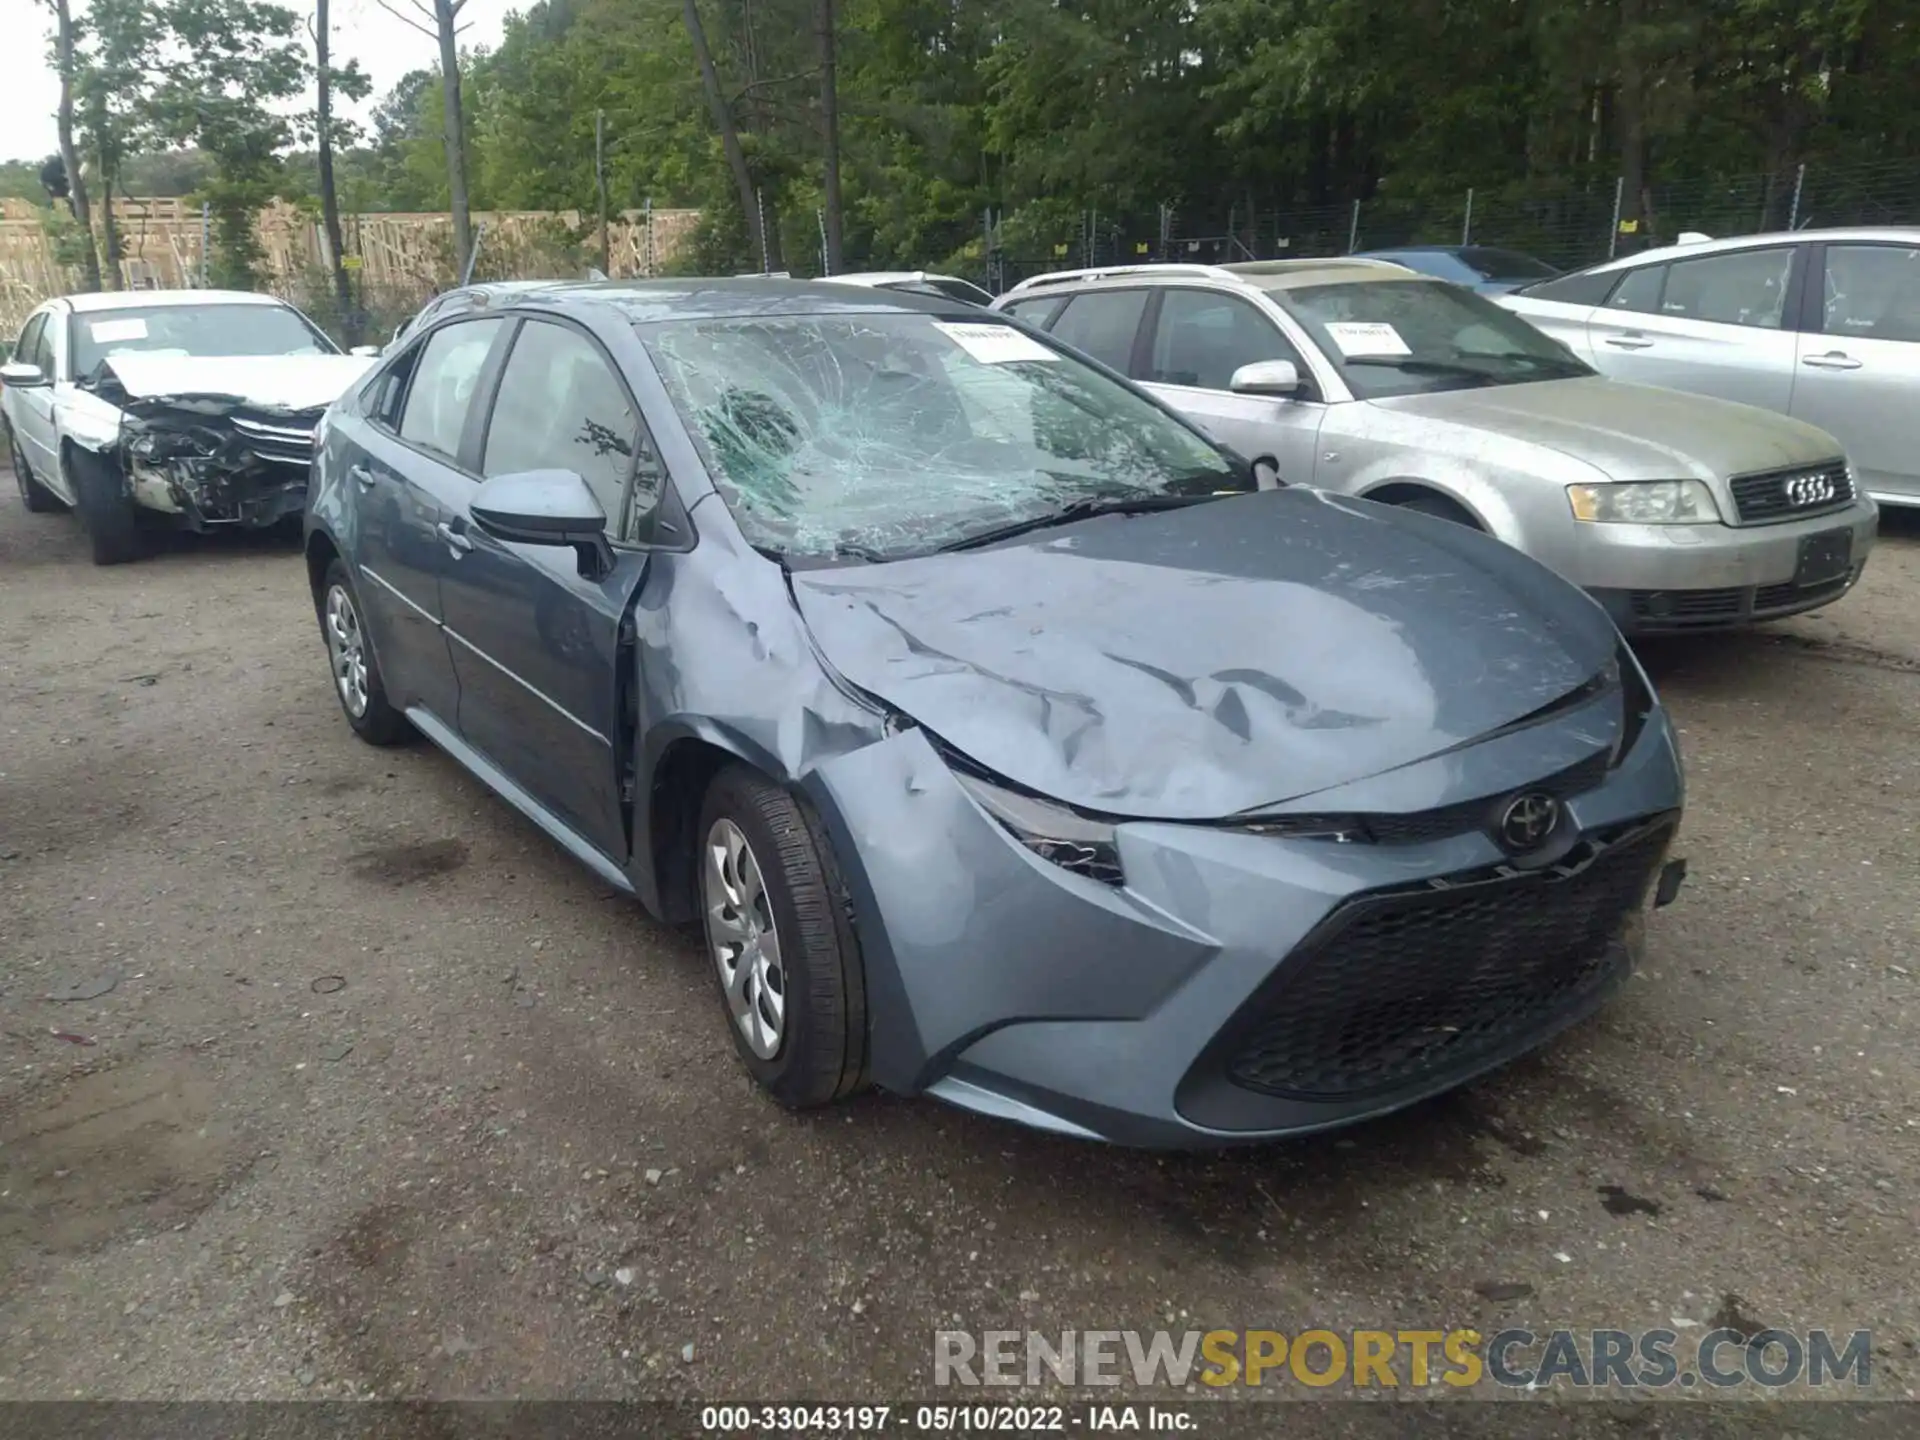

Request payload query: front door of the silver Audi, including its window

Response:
[1139,286,1327,486]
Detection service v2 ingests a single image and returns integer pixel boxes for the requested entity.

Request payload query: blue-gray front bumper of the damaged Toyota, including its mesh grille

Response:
[808,693,1682,1148]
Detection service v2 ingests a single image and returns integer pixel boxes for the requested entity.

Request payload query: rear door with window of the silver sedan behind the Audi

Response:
[1588,246,1805,415]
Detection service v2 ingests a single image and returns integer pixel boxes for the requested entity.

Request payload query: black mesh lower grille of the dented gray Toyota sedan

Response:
[1227,824,1670,1100]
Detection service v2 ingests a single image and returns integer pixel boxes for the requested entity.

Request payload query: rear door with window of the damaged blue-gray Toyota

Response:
[346,317,503,728]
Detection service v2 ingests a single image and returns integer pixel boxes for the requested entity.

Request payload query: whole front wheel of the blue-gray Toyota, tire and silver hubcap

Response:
[697,764,866,1110]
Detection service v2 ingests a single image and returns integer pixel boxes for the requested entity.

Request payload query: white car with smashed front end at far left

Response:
[0,290,376,564]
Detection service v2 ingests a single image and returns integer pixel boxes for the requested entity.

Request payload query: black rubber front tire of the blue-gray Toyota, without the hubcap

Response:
[695,764,868,1110]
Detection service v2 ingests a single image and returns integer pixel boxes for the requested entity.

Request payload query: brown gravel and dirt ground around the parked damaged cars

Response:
[0,484,1920,1434]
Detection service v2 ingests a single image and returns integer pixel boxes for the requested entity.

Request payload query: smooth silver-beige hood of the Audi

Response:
[1369,376,1841,480]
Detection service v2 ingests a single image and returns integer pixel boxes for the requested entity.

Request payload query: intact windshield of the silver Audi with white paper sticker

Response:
[1273,280,1594,399]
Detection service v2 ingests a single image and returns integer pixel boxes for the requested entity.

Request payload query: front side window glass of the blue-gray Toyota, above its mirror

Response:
[484,321,660,538]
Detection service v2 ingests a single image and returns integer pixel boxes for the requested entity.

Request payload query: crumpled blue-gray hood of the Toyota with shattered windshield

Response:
[793,490,1617,820]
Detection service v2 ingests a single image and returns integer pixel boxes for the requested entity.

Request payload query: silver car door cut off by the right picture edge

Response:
[1793,244,1920,505]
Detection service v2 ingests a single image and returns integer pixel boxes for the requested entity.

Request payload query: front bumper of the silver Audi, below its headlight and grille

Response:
[1557,497,1880,634]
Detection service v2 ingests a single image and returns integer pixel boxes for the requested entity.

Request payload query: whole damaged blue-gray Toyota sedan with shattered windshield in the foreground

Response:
[307,278,1682,1146]
